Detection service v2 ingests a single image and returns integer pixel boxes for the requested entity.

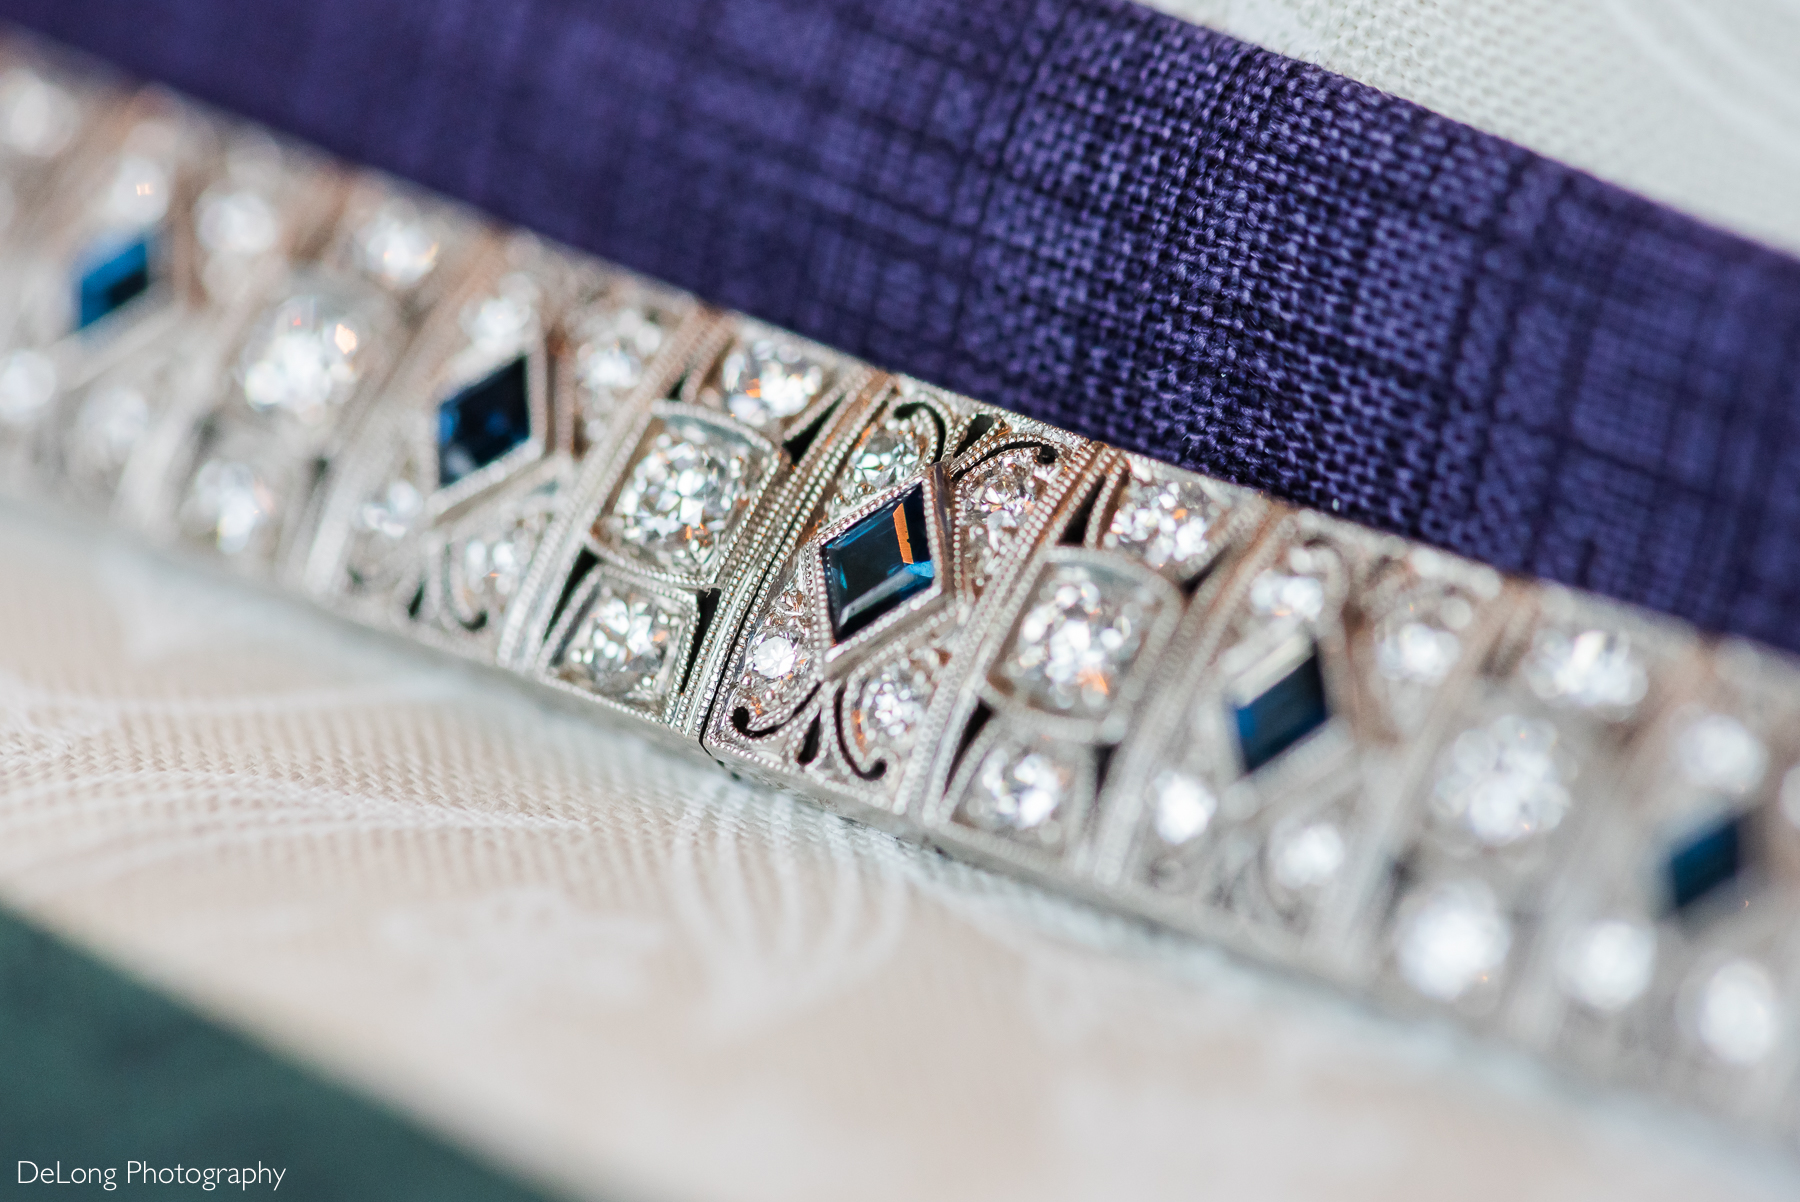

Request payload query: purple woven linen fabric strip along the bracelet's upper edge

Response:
[0,0,1800,648]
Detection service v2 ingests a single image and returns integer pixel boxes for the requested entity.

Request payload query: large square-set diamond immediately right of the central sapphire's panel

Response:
[1001,563,1156,716]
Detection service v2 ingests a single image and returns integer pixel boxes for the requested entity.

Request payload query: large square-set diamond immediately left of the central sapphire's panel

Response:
[607,421,763,574]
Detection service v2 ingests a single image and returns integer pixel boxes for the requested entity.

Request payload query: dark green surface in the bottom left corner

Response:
[0,912,561,1202]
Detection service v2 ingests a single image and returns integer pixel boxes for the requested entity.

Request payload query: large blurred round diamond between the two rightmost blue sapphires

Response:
[1433,714,1570,848]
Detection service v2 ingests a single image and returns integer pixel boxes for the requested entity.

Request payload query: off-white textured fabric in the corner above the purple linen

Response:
[1150,0,1800,250]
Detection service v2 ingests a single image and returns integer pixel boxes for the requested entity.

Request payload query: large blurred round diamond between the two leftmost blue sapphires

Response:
[238,292,385,428]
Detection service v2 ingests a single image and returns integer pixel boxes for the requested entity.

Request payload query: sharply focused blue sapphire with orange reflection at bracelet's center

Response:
[824,486,938,642]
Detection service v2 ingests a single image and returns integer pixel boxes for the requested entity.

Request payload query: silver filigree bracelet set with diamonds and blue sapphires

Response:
[0,49,1800,1137]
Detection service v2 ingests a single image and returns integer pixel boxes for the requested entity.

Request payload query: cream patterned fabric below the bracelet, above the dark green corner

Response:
[0,511,1800,1202]
